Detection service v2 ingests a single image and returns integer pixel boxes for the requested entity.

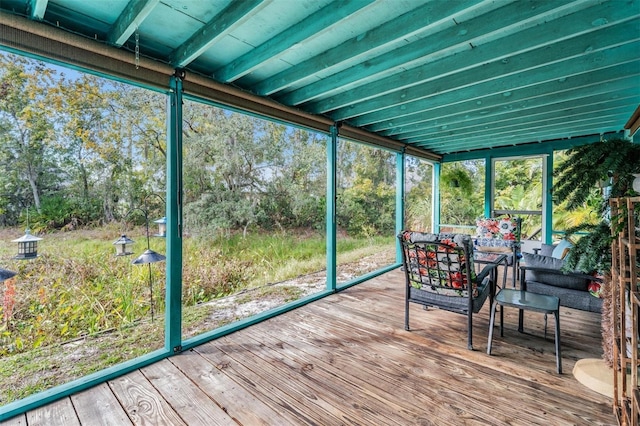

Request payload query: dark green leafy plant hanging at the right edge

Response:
[552,139,640,273]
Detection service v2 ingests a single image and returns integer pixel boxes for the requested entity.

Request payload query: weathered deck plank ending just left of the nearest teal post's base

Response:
[142,360,236,426]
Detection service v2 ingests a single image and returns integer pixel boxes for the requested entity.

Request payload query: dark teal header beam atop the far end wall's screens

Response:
[442,132,624,163]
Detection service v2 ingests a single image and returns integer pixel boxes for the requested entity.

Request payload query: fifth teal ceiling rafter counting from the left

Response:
[253,0,479,99]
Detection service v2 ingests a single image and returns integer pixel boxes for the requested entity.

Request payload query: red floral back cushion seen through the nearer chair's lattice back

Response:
[400,231,478,297]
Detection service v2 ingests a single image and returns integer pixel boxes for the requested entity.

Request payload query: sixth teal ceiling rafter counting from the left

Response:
[277,1,561,106]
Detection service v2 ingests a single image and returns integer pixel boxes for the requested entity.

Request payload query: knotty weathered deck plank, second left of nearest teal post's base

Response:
[109,370,185,426]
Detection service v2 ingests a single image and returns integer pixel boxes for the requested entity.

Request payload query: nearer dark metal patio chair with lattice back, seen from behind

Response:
[398,231,498,350]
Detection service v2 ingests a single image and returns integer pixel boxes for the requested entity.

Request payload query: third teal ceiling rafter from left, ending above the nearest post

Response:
[169,0,269,68]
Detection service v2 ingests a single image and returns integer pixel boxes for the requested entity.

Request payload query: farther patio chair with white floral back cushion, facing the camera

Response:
[474,217,522,287]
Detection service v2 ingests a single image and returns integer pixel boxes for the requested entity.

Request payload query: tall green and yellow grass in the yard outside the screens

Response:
[0,227,391,404]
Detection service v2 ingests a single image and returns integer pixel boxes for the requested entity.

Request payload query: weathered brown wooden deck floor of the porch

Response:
[4,270,616,425]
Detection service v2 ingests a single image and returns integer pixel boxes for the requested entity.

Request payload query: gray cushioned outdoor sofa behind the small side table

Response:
[520,244,602,312]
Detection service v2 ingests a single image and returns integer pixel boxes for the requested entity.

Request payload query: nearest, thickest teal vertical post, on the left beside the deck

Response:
[165,70,184,353]
